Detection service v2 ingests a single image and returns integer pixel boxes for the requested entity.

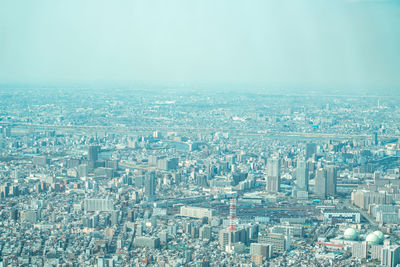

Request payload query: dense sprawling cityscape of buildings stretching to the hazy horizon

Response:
[0,87,400,267]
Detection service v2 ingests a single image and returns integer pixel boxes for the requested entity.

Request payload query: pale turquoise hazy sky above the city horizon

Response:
[0,0,400,91]
